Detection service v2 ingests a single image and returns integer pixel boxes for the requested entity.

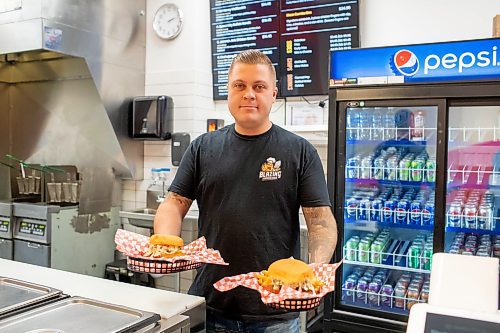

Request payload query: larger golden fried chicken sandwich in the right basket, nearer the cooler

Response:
[257,258,324,295]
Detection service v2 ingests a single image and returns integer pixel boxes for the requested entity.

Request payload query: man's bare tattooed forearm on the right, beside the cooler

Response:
[302,206,337,263]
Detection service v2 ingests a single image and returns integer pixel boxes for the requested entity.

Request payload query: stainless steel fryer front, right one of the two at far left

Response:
[12,203,60,267]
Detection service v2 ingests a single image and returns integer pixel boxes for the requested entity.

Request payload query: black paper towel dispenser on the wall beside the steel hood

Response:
[130,95,174,140]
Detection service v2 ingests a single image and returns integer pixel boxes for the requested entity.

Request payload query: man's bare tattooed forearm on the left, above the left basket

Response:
[154,192,193,236]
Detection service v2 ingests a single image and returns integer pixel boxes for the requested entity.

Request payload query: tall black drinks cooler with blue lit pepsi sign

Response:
[324,39,500,333]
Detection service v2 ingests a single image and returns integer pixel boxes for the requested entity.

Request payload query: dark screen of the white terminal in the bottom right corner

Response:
[424,313,500,333]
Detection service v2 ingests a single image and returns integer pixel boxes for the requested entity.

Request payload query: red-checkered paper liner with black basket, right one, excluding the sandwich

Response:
[214,262,342,311]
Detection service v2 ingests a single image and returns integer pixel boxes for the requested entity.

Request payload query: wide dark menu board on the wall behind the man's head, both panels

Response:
[210,0,359,99]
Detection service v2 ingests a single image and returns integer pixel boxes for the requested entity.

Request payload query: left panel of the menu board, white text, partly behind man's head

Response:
[210,0,279,99]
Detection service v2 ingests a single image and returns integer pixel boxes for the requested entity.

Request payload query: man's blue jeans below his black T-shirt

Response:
[207,313,300,333]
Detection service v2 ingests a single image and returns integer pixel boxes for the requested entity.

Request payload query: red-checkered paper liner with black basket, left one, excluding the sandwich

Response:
[115,229,228,274]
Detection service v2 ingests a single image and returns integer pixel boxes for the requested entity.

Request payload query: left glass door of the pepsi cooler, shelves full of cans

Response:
[336,101,438,317]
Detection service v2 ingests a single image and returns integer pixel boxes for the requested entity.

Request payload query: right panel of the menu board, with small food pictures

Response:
[280,0,359,96]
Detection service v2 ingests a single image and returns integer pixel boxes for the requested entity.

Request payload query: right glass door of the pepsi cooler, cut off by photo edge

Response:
[444,101,500,264]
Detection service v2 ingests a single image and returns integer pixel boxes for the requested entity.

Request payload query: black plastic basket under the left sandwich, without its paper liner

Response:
[127,257,201,274]
